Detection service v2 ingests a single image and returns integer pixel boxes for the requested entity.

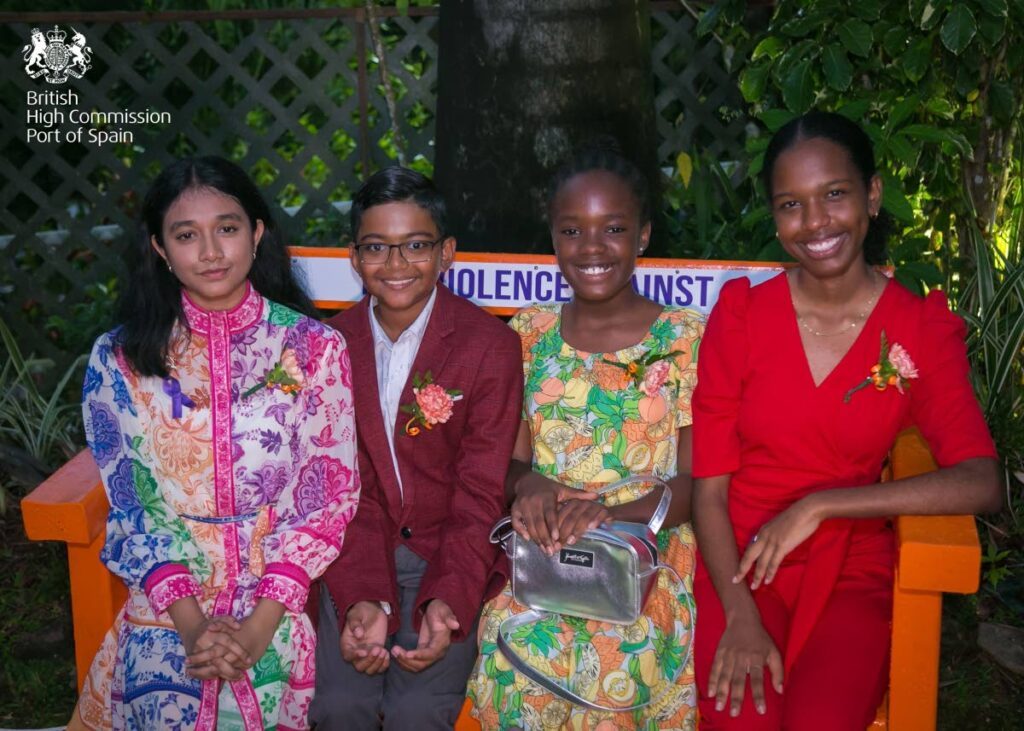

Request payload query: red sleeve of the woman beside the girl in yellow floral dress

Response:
[693,276,751,477]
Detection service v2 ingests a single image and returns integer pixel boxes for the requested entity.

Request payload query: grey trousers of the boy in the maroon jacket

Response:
[309,546,476,731]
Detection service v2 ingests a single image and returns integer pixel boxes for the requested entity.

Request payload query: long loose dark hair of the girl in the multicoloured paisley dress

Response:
[117,156,316,378]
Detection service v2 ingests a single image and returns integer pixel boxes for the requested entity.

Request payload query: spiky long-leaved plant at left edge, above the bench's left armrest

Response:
[0,320,87,514]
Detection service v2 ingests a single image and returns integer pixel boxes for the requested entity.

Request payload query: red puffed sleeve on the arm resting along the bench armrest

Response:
[910,291,996,467]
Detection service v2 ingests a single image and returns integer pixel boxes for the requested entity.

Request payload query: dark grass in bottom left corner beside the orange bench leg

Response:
[0,505,76,728]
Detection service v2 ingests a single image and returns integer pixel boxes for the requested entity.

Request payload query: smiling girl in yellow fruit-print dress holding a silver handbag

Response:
[469,147,703,731]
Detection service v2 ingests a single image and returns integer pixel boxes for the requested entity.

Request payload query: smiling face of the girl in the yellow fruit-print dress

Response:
[551,170,650,302]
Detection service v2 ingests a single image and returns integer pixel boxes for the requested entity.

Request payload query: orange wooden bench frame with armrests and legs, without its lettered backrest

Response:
[22,423,981,731]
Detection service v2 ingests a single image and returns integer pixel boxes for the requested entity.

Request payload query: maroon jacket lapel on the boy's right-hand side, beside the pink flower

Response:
[393,284,455,521]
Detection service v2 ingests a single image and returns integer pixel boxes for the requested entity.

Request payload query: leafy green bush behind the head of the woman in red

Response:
[694,0,1024,291]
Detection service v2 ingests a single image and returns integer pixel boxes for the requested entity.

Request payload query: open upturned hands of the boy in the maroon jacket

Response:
[341,599,459,675]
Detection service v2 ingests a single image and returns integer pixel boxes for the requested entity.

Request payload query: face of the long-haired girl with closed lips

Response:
[150,187,263,310]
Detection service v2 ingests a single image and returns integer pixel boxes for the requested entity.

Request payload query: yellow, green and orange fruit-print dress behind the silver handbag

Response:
[468,305,705,731]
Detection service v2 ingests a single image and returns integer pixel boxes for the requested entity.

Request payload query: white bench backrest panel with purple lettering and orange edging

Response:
[291,247,782,314]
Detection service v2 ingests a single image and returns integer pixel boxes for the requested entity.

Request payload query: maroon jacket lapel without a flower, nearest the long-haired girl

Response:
[348,297,402,516]
